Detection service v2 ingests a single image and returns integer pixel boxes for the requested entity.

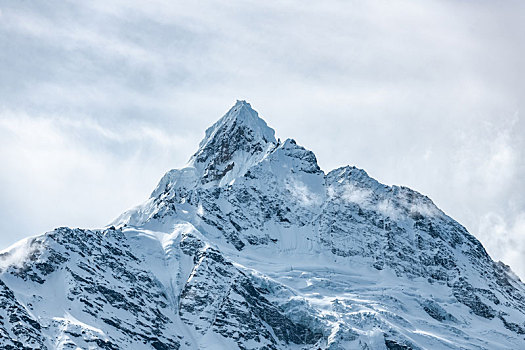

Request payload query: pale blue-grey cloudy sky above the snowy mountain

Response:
[0,0,525,279]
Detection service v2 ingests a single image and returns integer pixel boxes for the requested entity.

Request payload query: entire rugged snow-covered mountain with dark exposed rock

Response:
[0,101,525,350]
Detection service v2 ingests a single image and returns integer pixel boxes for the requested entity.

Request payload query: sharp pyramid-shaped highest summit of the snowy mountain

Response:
[190,100,277,184]
